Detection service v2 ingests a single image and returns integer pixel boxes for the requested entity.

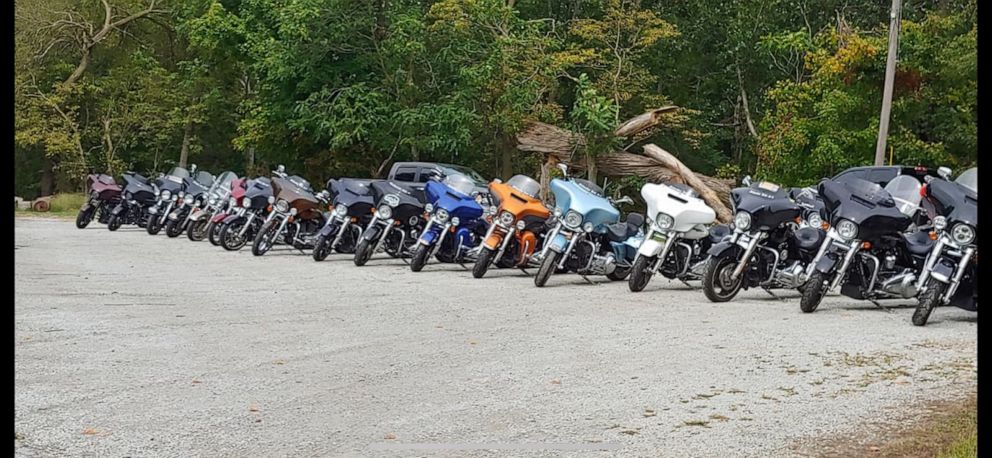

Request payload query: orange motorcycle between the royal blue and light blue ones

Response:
[472,175,551,278]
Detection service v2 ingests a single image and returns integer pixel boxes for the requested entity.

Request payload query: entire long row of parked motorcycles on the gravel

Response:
[76,161,978,326]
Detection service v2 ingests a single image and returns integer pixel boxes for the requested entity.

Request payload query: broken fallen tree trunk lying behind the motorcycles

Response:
[517,106,734,223]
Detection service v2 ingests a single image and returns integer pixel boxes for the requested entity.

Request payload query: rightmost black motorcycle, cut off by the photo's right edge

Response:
[913,167,978,326]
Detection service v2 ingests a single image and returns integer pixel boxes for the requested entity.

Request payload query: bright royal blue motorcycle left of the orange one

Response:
[410,174,489,272]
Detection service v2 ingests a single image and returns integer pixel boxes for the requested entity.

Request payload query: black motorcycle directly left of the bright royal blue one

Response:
[354,180,427,266]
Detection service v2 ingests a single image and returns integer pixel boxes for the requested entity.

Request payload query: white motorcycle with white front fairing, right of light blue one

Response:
[627,183,730,292]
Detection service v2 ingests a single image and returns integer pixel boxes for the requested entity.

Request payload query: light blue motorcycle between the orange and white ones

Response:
[534,164,644,287]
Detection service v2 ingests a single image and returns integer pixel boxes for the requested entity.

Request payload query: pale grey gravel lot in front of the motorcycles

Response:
[14,218,977,457]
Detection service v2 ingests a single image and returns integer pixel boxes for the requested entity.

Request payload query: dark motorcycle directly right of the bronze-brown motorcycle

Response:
[312,178,375,261]
